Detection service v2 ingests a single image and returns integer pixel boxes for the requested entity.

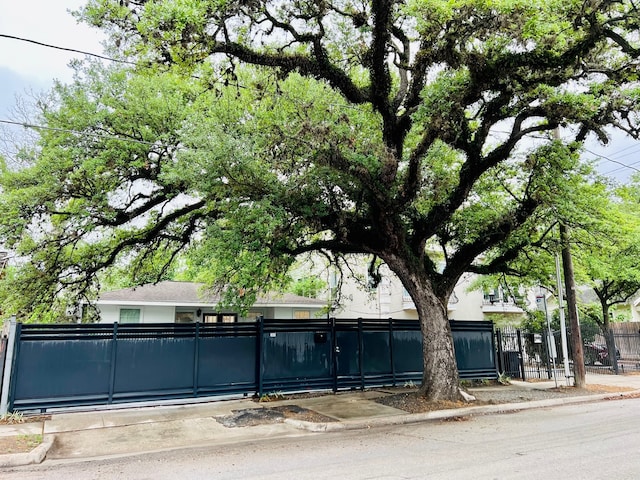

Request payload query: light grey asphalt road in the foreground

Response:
[5,399,640,480]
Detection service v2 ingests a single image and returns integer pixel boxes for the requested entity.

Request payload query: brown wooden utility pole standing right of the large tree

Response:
[560,223,586,388]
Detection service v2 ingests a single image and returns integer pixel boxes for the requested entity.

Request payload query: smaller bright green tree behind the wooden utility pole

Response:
[472,176,640,376]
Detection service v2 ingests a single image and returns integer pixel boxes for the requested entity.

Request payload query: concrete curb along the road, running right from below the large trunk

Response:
[285,390,640,433]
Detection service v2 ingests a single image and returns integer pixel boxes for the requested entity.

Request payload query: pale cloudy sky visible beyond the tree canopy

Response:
[0,0,640,183]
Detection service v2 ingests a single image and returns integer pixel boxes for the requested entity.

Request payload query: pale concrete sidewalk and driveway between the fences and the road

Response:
[0,374,640,467]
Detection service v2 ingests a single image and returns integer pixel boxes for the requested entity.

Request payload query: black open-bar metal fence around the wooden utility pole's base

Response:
[496,322,640,380]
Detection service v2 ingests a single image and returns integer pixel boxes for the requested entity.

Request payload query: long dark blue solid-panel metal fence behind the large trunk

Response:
[2,319,497,411]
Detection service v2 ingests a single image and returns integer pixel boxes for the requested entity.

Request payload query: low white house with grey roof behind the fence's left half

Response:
[96,281,326,323]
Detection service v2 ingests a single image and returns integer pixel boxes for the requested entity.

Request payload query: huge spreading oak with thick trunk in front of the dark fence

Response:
[2,0,640,400]
